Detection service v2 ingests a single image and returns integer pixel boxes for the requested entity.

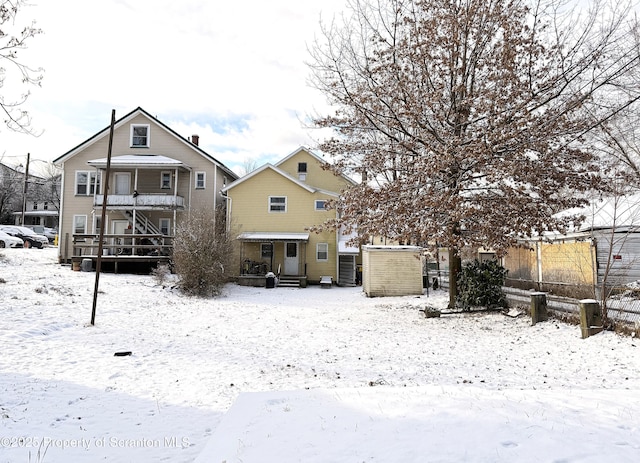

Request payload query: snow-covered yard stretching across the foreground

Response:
[0,248,640,463]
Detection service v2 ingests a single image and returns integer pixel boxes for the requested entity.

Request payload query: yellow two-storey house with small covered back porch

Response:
[223,147,359,286]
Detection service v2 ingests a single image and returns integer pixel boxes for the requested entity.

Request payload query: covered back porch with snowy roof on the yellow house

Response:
[237,232,309,287]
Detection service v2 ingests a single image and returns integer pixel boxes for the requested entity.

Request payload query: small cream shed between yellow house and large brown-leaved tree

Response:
[362,245,423,297]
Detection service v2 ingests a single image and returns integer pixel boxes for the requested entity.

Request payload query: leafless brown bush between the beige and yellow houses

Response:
[173,207,233,297]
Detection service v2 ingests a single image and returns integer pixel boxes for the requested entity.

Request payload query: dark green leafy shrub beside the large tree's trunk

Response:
[458,259,507,309]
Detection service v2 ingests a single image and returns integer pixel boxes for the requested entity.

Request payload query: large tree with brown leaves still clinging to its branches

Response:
[310,0,640,312]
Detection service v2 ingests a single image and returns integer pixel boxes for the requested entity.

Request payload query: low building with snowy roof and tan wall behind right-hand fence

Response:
[503,194,640,299]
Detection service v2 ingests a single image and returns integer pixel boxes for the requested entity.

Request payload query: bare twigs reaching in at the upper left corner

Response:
[0,0,43,133]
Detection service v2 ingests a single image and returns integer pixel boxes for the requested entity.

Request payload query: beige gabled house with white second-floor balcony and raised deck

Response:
[54,108,238,262]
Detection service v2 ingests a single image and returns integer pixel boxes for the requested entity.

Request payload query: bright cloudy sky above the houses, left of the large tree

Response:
[0,0,346,176]
